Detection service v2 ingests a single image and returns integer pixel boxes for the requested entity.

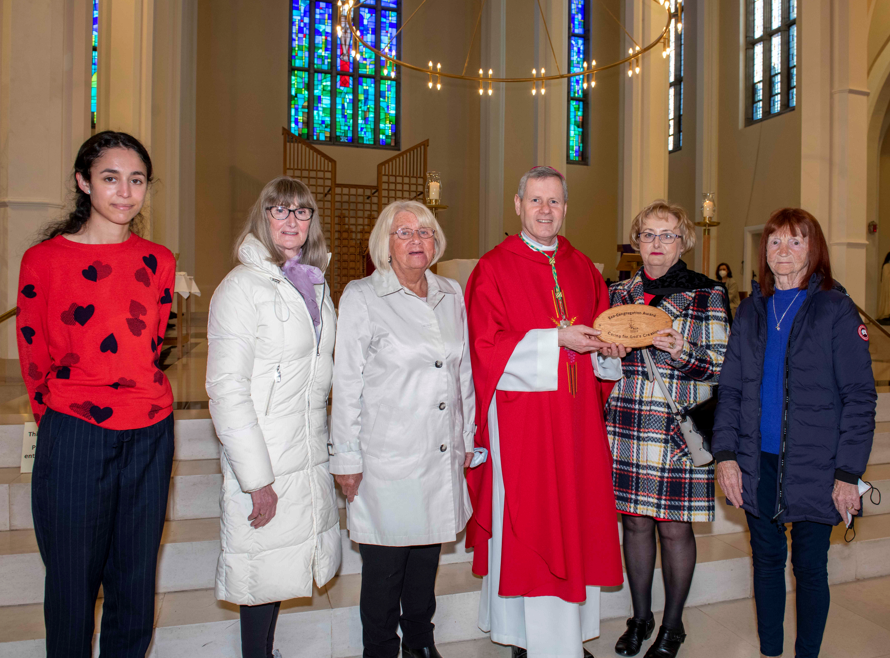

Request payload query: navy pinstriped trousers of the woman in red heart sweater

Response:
[31,409,173,658]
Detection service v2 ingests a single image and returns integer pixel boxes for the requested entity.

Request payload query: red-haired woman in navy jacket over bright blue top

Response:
[712,208,877,658]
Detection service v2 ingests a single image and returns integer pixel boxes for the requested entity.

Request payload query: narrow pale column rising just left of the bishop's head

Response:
[479,0,512,256]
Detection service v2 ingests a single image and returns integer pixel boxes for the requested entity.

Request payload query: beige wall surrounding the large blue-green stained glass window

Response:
[196,0,480,307]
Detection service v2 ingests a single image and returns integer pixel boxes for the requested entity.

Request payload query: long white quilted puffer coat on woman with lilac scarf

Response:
[207,236,341,605]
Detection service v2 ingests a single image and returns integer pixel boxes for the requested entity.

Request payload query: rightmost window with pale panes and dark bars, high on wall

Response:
[747,0,797,124]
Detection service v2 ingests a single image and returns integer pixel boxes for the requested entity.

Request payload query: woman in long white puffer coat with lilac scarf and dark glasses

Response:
[207,177,341,658]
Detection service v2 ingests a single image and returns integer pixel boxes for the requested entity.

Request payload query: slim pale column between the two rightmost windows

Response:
[688,0,720,280]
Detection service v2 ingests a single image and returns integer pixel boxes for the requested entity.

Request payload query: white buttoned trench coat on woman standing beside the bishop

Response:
[331,270,476,546]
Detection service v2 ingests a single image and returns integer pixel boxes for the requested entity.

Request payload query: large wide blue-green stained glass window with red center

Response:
[289,0,401,148]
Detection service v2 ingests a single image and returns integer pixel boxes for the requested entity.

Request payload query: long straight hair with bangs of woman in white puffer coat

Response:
[235,176,328,272]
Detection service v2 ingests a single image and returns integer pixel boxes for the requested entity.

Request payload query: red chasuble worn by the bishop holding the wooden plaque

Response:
[466,236,623,602]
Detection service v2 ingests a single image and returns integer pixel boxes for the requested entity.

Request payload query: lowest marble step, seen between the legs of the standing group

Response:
[0,516,890,658]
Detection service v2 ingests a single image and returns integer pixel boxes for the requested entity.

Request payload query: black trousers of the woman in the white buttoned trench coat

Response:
[359,544,442,658]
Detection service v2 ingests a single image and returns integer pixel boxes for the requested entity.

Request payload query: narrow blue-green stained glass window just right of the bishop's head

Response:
[567,0,590,164]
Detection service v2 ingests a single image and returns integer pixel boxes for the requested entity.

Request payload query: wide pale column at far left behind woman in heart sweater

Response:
[0,0,92,365]
